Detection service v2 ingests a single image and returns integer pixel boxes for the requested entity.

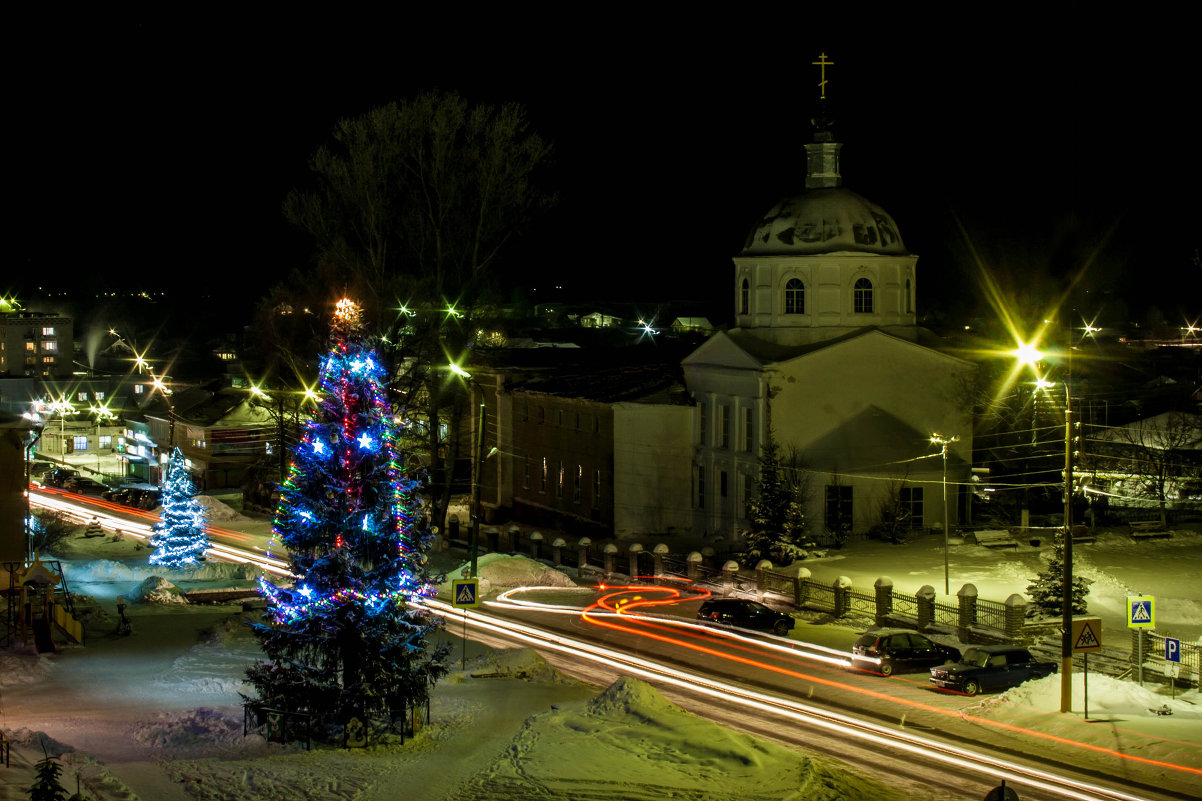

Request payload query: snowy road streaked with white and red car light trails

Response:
[31,490,1202,801]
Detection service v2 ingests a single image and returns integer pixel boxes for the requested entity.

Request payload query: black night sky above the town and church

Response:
[11,12,1202,329]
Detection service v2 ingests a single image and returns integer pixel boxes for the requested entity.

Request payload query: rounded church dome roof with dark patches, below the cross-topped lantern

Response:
[742,185,906,256]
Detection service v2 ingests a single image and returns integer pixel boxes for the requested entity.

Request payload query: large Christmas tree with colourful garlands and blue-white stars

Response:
[246,299,447,730]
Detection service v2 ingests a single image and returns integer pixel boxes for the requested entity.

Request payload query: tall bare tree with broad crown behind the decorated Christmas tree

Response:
[258,93,554,522]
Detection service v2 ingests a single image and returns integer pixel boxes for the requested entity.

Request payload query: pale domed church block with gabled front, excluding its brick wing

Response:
[683,79,974,541]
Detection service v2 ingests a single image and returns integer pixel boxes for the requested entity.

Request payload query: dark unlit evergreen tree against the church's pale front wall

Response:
[740,435,805,566]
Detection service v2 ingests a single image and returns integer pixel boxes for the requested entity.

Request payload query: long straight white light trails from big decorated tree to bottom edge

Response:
[424,596,1163,801]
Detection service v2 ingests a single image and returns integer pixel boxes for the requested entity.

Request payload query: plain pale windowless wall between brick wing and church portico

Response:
[613,403,697,536]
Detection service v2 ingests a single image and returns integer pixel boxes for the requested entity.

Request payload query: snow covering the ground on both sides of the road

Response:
[0,524,1202,801]
